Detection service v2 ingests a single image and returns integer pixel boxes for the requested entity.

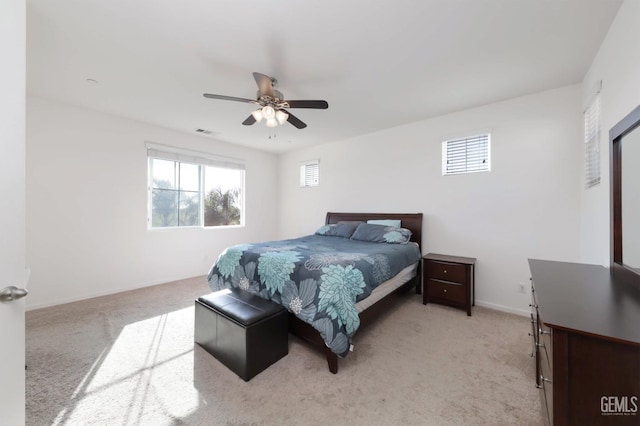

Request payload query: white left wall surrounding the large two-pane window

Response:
[26,96,278,309]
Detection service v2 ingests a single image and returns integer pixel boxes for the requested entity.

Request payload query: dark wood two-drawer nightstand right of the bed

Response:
[422,253,476,316]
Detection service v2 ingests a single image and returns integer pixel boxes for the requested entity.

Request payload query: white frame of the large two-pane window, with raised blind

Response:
[145,142,246,231]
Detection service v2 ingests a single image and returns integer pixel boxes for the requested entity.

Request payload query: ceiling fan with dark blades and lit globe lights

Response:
[204,72,329,129]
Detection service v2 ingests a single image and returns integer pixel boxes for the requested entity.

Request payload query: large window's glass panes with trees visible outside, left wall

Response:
[149,152,244,228]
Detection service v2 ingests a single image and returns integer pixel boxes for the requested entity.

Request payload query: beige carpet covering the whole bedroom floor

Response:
[26,277,542,426]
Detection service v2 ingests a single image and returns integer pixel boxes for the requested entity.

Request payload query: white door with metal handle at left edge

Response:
[0,0,26,426]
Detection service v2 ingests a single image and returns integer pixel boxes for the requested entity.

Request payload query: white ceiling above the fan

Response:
[27,0,622,152]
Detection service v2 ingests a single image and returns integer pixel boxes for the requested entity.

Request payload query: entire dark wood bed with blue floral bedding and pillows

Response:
[208,212,422,374]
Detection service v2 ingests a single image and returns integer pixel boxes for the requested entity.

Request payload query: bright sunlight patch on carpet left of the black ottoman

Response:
[54,308,199,424]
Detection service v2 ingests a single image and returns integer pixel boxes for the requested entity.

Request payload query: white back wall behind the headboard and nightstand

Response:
[278,86,582,313]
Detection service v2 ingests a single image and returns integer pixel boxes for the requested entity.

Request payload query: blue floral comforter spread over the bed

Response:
[208,235,420,357]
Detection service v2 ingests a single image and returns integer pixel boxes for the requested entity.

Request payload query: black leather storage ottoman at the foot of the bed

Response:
[194,288,289,381]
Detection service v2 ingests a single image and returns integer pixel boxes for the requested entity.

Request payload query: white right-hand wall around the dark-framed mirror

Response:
[580,0,640,266]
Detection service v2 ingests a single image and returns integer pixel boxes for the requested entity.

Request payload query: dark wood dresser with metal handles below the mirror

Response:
[529,259,640,425]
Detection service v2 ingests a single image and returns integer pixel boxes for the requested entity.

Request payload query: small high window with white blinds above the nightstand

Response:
[442,133,491,176]
